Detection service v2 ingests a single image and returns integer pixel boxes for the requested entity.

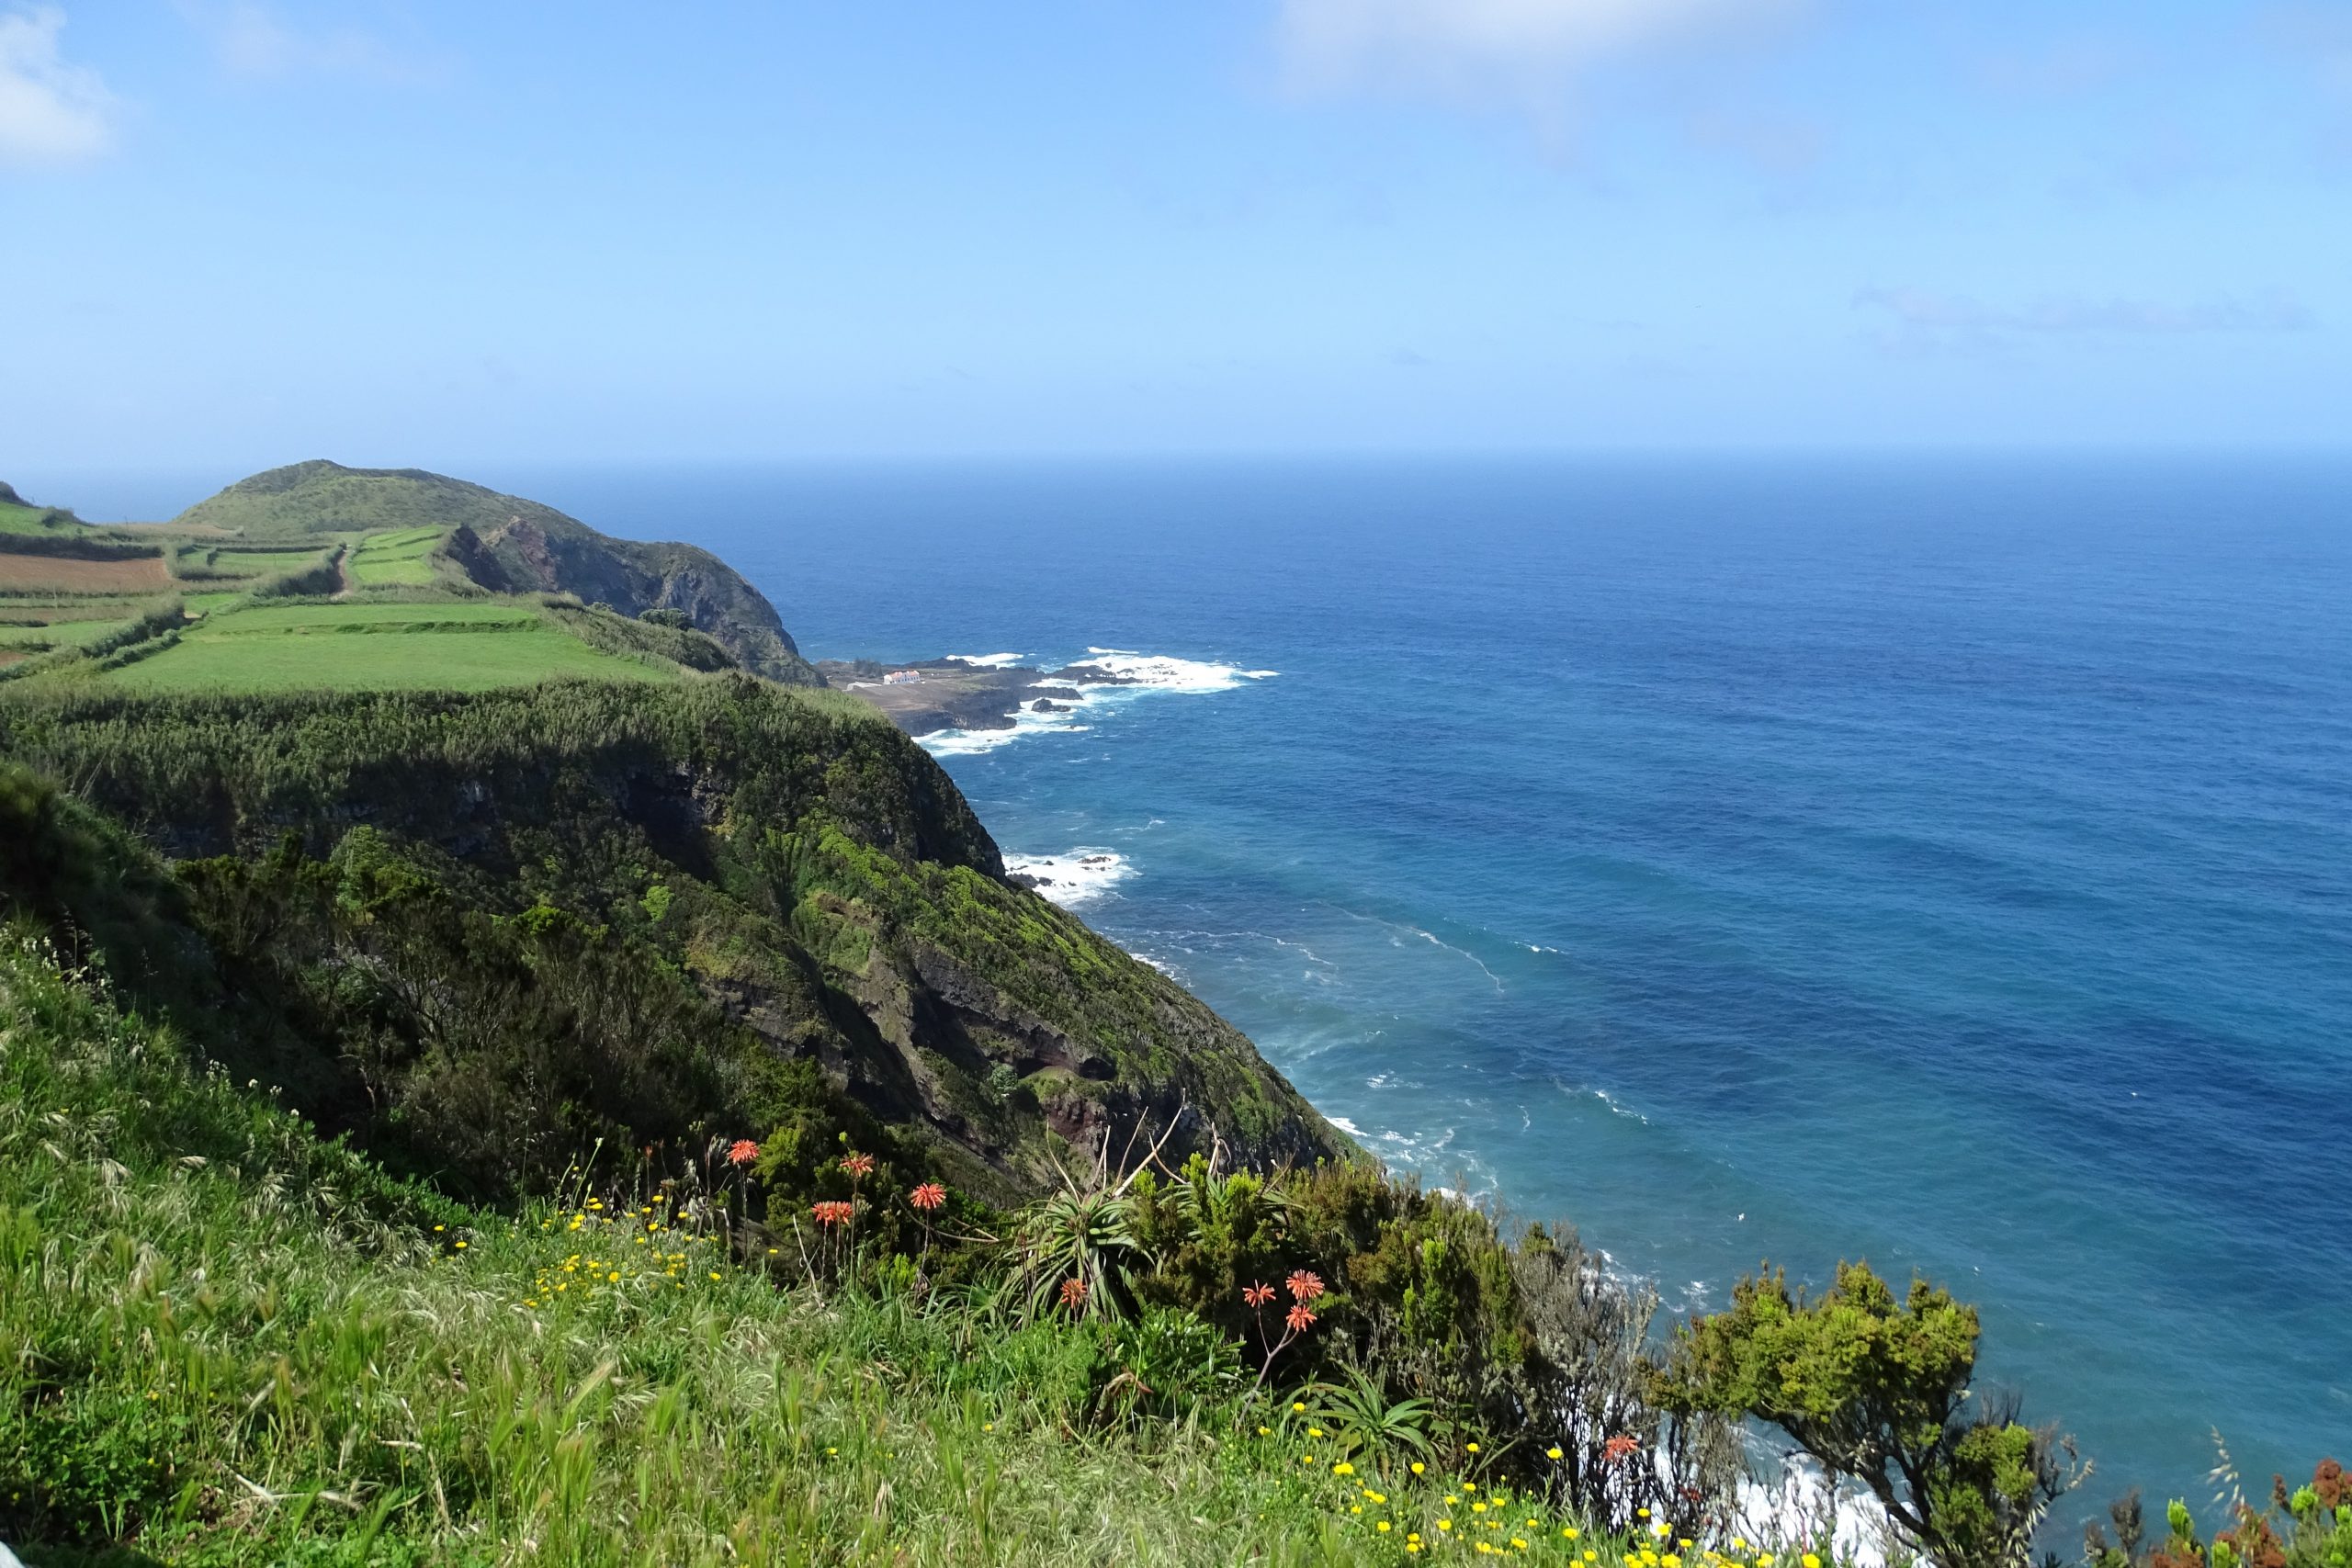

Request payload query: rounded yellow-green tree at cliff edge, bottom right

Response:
[1660,1262,2082,1568]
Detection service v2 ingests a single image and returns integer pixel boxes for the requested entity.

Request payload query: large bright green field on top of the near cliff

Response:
[101,604,668,691]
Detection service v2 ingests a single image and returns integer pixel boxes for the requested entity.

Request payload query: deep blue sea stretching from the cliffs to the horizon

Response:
[45,458,2352,1514]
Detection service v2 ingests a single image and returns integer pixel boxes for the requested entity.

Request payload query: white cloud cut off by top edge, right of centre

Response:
[1282,0,1802,96]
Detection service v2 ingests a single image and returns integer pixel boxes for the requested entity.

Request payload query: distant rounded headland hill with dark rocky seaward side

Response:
[174,461,823,686]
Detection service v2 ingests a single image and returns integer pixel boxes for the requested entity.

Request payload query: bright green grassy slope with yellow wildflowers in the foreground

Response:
[0,936,1696,1568]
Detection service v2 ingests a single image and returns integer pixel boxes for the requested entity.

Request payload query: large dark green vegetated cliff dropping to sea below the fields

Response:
[0,682,1350,1197]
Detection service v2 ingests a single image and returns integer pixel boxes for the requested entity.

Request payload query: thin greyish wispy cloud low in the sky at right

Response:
[1853,289,2319,353]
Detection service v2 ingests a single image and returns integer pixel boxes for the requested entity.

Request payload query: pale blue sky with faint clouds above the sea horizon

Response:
[0,0,2352,475]
